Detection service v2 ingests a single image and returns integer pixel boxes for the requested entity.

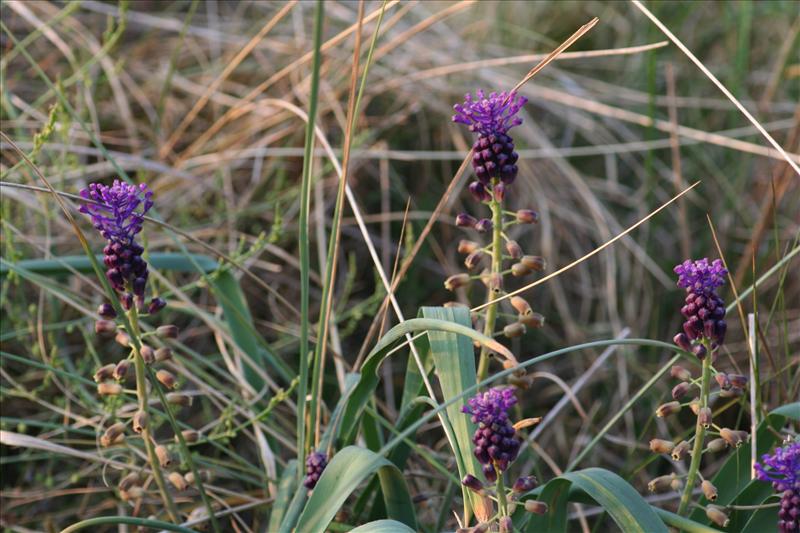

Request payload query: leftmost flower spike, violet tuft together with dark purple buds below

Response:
[80,180,153,302]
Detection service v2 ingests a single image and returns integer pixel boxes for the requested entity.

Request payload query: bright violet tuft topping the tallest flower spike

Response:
[453,89,528,135]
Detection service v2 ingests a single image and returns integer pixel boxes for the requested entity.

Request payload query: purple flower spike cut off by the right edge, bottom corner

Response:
[755,442,800,533]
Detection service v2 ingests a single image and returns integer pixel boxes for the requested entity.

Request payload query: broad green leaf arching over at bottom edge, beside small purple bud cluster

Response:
[295,446,417,533]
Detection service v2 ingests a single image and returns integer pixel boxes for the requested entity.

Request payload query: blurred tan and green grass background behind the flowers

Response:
[0,0,800,530]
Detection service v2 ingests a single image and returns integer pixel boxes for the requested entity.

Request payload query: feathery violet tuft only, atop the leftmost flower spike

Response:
[80,180,153,244]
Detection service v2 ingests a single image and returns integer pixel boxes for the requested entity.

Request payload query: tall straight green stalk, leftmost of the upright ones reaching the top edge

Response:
[297,0,325,476]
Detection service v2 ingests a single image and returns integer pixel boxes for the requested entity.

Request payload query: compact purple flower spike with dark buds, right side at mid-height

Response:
[674,258,728,359]
